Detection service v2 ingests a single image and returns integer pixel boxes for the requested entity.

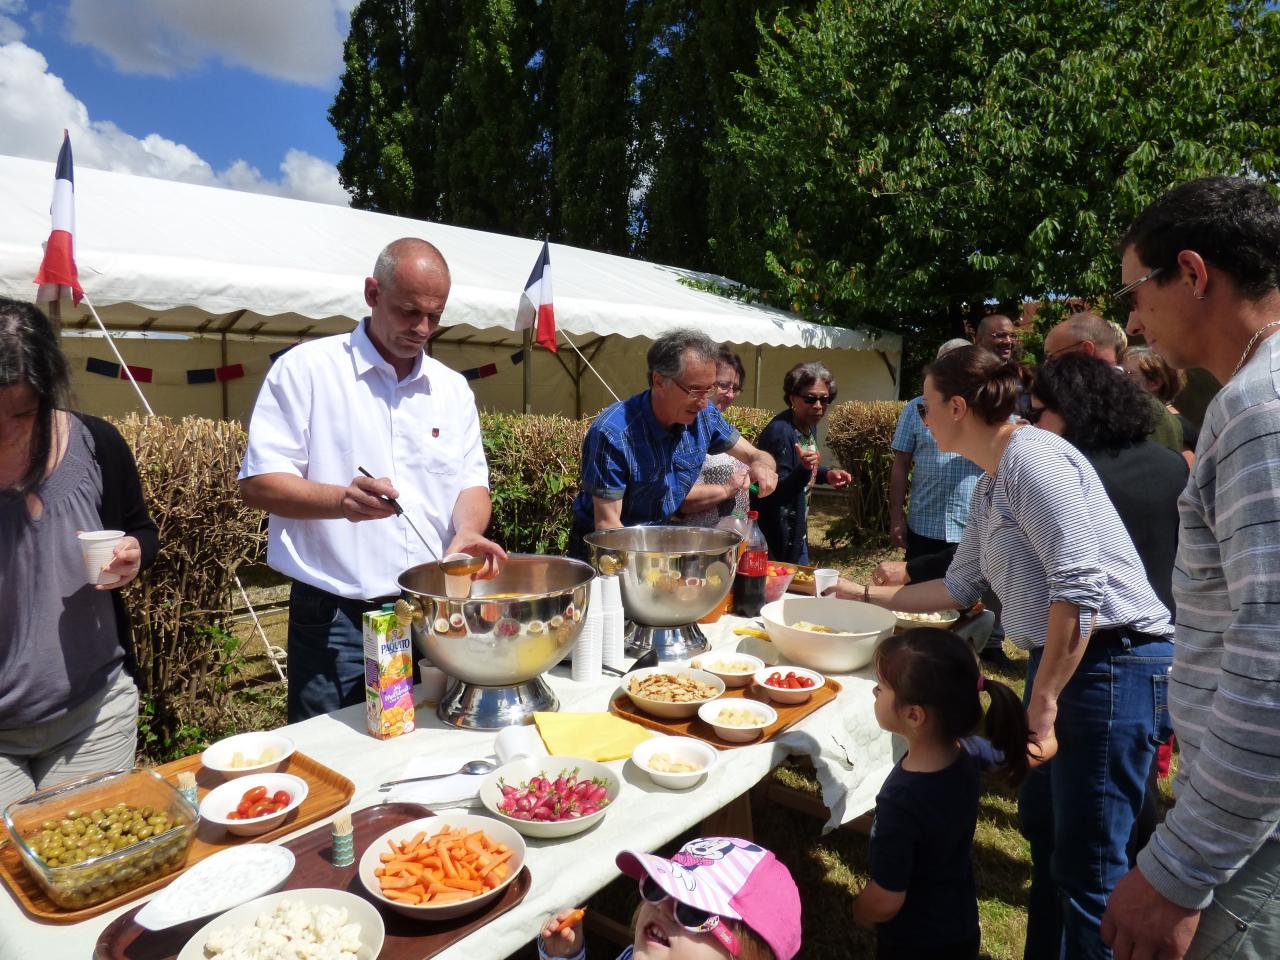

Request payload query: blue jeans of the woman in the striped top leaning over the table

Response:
[1018,628,1174,960]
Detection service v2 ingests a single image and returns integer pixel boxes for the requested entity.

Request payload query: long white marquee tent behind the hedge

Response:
[0,156,901,419]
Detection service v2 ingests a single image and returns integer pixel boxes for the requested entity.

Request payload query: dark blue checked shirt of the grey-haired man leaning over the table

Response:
[573,390,739,530]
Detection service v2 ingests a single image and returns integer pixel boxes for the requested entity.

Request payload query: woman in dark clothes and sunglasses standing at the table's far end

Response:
[751,362,851,563]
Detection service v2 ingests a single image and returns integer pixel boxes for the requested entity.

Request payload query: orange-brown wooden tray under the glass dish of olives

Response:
[0,753,356,923]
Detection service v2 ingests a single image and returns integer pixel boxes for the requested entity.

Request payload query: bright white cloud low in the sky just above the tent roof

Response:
[0,42,349,204]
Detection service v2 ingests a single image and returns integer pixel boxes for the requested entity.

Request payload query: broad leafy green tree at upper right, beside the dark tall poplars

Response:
[728,0,1280,344]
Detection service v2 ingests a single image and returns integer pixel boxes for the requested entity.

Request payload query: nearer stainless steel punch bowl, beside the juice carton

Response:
[399,553,595,730]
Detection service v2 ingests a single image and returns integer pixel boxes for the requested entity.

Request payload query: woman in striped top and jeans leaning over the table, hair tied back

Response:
[842,347,1172,960]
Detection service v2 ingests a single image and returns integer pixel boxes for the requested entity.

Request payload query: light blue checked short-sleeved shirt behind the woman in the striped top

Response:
[891,397,982,543]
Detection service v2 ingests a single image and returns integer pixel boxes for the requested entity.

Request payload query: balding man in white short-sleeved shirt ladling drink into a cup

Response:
[239,238,506,723]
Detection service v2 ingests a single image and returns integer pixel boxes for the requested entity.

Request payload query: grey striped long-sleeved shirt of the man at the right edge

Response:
[1138,335,1280,909]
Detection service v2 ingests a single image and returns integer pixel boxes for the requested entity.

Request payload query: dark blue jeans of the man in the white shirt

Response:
[289,580,394,723]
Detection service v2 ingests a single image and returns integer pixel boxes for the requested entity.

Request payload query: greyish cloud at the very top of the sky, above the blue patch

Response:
[67,0,355,87]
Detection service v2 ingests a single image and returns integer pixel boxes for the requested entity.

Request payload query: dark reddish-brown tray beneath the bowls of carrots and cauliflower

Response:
[93,804,532,960]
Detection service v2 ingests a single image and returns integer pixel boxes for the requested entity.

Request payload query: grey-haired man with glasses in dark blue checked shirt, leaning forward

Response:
[568,329,777,559]
